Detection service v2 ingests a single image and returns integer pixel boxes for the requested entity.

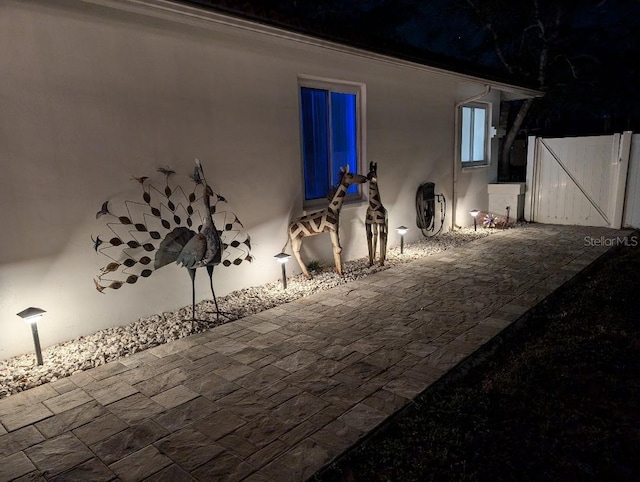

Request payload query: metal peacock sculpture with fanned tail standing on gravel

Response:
[92,159,253,325]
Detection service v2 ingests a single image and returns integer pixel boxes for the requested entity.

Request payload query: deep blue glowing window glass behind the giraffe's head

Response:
[300,86,359,201]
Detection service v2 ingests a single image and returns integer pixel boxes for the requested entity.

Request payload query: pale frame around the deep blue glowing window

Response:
[297,75,367,210]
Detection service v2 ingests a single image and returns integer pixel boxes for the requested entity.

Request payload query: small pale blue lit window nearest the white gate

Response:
[460,105,489,166]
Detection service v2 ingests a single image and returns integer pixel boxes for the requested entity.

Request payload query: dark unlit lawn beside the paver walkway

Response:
[316,235,640,481]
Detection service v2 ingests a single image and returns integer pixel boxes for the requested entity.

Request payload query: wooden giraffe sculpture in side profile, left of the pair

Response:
[282,166,367,279]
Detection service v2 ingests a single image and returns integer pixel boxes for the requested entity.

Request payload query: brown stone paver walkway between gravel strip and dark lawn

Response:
[0,225,627,482]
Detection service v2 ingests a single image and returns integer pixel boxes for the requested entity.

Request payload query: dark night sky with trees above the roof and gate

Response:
[183,0,640,135]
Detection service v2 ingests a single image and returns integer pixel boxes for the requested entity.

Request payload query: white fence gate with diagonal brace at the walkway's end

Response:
[525,132,640,228]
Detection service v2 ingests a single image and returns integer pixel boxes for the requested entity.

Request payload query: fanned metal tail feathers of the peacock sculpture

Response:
[91,162,253,293]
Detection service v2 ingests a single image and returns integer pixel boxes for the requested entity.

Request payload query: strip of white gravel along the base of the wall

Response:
[0,228,496,399]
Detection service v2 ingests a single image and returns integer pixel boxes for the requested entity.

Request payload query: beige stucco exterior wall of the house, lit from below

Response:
[0,0,510,359]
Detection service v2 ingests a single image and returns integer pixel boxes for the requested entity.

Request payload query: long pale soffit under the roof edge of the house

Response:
[82,0,544,100]
